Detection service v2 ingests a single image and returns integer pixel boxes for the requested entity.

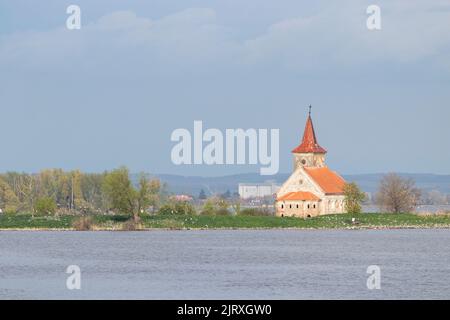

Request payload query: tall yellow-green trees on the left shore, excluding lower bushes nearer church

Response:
[0,167,164,219]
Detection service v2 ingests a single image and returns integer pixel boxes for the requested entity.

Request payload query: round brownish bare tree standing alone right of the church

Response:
[375,173,420,213]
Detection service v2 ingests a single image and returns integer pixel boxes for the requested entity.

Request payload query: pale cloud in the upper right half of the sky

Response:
[245,1,450,69]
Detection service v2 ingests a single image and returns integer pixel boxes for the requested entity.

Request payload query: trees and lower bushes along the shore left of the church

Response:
[0,167,269,222]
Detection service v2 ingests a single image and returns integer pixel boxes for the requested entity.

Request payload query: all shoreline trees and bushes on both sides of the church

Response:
[0,167,428,221]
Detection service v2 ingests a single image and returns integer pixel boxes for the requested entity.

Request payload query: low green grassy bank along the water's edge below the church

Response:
[0,213,450,230]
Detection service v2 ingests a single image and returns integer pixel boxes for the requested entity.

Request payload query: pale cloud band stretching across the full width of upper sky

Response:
[0,1,450,73]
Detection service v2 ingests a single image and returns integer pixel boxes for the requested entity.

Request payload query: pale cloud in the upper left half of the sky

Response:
[0,9,237,71]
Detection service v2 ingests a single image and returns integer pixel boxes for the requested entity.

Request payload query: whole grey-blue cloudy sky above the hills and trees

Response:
[0,0,450,176]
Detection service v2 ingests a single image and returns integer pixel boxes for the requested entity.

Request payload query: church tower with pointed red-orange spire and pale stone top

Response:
[292,106,327,171]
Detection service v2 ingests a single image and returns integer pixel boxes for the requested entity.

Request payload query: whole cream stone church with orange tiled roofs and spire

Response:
[275,107,346,218]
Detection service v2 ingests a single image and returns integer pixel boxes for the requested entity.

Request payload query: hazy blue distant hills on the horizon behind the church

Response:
[137,173,450,196]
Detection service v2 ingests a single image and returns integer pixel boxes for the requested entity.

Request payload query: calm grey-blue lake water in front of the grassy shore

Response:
[0,230,450,299]
